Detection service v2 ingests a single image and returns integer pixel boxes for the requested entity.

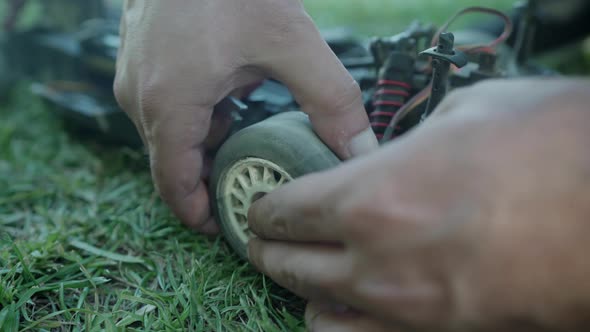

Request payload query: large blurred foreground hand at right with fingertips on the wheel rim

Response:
[249,79,590,332]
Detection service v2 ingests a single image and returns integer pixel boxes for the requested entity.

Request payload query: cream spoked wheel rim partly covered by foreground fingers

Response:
[218,157,293,244]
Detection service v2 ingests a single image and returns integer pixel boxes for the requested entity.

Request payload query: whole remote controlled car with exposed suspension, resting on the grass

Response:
[0,1,572,258]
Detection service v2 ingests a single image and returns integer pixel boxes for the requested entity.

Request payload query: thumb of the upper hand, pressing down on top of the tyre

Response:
[262,14,378,159]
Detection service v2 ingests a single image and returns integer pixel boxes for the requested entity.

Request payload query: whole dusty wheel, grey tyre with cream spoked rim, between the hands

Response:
[209,112,340,259]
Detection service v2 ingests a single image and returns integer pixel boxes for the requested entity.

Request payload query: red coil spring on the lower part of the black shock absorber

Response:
[369,79,412,140]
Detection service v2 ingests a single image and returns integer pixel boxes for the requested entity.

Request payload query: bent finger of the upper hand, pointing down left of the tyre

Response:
[146,102,218,234]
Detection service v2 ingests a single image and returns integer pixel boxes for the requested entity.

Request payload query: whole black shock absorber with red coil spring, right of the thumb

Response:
[369,51,415,140]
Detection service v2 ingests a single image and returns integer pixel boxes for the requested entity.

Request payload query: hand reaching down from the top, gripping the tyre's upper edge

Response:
[114,0,377,233]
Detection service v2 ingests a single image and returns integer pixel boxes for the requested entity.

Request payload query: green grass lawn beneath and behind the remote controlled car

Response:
[0,0,584,331]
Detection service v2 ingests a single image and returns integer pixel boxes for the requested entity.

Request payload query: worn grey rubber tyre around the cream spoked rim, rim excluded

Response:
[209,112,341,260]
